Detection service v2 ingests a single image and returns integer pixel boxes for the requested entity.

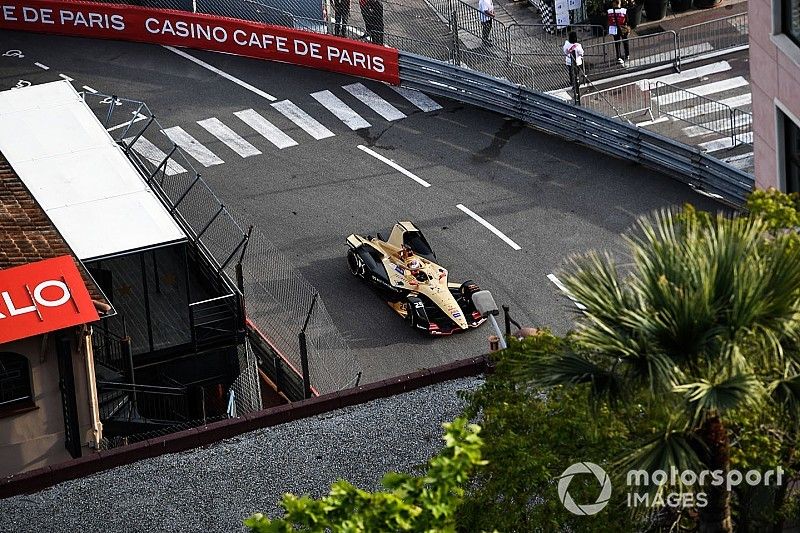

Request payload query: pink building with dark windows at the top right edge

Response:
[748,0,800,192]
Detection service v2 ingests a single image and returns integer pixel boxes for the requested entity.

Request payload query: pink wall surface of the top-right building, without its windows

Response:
[748,0,800,189]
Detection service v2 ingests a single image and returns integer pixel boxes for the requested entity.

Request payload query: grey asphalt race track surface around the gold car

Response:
[0,32,719,381]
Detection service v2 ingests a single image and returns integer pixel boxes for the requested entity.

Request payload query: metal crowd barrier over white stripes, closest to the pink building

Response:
[649,81,753,146]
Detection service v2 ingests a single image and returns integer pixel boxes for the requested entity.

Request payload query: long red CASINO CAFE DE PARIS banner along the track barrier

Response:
[0,0,400,85]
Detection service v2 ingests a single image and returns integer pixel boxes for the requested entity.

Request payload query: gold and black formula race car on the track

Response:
[347,222,486,335]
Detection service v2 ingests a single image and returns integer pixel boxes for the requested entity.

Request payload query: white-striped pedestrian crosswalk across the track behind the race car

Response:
[124,82,442,171]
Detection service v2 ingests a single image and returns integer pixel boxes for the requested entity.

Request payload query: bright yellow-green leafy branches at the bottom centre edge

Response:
[244,418,486,533]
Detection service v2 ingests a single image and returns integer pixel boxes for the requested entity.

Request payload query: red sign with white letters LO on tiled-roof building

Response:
[0,255,100,344]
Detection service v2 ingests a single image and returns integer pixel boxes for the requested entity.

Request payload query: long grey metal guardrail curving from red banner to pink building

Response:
[400,53,754,206]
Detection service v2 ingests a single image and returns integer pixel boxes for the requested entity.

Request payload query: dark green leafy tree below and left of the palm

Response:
[458,332,658,533]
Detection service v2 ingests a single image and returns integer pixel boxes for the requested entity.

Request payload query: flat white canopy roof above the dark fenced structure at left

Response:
[0,81,186,260]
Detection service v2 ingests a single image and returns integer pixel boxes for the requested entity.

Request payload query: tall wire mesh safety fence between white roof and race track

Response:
[84,93,360,393]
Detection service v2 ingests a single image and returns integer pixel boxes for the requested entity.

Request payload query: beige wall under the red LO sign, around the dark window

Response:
[0,334,99,477]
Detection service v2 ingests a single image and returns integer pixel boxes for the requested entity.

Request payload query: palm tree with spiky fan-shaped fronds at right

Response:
[521,210,800,532]
